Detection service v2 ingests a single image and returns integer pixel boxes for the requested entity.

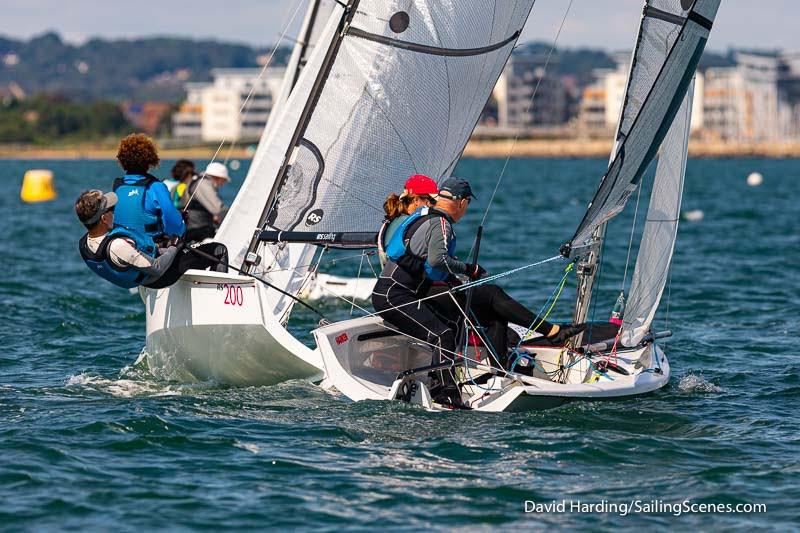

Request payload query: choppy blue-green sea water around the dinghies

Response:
[0,159,800,530]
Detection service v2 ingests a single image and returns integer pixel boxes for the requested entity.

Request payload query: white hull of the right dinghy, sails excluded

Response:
[314,317,670,412]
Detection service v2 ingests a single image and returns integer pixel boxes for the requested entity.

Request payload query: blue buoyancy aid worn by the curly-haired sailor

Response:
[113,174,164,240]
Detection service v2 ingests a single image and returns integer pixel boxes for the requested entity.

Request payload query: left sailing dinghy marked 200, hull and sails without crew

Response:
[145,0,534,384]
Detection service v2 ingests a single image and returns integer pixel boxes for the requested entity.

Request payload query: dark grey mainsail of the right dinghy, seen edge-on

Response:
[570,0,720,252]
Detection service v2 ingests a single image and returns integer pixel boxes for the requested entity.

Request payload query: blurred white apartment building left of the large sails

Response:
[172,68,285,141]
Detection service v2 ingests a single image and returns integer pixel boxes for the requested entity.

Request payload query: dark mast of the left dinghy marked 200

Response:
[244,0,359,273]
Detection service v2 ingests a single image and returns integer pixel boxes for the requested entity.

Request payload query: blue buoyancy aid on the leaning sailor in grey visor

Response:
[78,226,156,289]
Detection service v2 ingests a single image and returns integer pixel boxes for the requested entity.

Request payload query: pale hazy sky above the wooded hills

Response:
[0,0,800,51]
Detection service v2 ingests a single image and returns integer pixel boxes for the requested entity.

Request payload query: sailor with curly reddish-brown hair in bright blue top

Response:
[113,133,186,249]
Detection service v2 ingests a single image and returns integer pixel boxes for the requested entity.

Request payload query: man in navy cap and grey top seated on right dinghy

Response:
[372,178,585,406]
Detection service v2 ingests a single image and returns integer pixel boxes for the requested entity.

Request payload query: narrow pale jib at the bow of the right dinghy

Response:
[620,77,694,346]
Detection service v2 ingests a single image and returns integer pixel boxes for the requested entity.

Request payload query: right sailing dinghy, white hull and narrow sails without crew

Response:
[314,0,719,411]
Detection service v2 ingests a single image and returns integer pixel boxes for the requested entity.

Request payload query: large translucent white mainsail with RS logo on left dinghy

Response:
[266,0,533,232]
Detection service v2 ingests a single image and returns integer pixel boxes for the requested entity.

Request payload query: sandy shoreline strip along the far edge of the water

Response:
[0,139,800,160]
